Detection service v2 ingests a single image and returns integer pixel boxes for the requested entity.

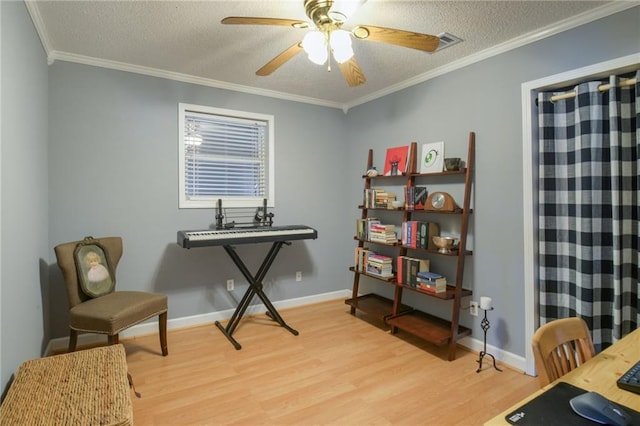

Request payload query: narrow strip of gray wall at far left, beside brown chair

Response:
[0,2,51,391]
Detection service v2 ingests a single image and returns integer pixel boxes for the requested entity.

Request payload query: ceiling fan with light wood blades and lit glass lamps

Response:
[222,0,440,87]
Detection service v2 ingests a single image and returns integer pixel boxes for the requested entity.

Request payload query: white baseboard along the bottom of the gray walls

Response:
[45,290,526,371]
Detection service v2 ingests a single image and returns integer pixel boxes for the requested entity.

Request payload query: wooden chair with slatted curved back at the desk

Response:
[532,317,595,387]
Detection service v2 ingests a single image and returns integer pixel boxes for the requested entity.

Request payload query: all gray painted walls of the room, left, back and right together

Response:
[0,2,640,392]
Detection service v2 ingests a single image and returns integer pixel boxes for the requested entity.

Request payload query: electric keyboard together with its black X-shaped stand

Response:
[178,225,318,350]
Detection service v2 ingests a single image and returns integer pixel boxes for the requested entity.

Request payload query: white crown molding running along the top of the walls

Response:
[25,0,640,114]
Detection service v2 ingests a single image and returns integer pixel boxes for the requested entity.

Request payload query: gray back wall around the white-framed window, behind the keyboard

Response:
[49,62,352,337]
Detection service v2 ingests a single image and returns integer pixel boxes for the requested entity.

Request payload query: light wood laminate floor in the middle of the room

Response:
[121,300,538,425]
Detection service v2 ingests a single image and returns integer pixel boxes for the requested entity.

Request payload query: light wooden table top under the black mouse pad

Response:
[485,328,640,426]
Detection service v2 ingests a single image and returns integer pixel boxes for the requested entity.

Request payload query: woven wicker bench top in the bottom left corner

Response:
[0,345,133,426]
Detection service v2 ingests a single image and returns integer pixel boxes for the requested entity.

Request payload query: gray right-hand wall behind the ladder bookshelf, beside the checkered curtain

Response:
[349,7,640,356]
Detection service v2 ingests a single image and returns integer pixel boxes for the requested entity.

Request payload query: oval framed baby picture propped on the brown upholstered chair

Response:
[73,238,116,297]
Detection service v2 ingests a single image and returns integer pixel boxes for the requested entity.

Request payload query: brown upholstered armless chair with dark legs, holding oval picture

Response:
[54,237,168,356]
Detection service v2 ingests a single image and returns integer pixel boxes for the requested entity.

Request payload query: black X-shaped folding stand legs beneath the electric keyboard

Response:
[215,241,298,350]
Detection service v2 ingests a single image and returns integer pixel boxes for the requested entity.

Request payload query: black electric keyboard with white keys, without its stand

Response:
[178,225,318,248]
